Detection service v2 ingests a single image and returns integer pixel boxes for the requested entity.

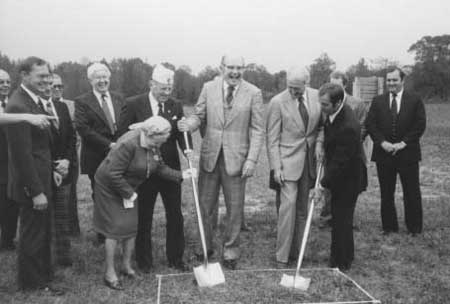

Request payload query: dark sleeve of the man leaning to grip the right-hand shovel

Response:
[321,128,360,188]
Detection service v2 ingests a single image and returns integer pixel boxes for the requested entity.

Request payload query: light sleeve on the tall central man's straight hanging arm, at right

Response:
[247,90,265,163]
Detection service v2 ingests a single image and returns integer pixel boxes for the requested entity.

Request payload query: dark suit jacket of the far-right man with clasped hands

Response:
[366,91,426,164]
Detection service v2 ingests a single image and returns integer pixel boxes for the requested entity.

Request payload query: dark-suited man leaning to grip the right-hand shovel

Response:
[318,83,363,271]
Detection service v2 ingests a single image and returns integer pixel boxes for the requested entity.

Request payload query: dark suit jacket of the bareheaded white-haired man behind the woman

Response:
[75,91,124,175]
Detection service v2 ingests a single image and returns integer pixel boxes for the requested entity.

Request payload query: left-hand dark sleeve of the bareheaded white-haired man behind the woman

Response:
[75,101,111,151]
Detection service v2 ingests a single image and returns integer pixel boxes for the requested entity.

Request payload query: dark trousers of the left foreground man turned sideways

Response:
[17,201,53,290]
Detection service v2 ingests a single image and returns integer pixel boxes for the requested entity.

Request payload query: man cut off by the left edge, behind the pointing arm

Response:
[0,69,19,250]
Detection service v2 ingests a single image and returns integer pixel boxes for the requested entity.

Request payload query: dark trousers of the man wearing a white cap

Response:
[135,176,185,267]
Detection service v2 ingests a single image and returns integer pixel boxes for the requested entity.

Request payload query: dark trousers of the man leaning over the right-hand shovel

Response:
[330,181,358,269]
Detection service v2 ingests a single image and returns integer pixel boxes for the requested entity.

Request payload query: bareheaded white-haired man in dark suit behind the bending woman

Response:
[75,62,124,242]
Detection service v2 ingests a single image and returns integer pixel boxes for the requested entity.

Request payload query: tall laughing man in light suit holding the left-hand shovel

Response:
[178,56,264,269]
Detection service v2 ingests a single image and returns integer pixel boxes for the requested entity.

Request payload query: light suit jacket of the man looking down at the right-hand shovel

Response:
[266,88,323,181]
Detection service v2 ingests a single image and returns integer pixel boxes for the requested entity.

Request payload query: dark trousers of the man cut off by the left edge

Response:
[0,184,19,245]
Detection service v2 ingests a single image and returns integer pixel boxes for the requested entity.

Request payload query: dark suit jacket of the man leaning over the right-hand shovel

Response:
[321,103,364,192]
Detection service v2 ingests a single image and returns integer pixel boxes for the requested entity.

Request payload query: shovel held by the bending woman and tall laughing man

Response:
[184,132,225,287]
